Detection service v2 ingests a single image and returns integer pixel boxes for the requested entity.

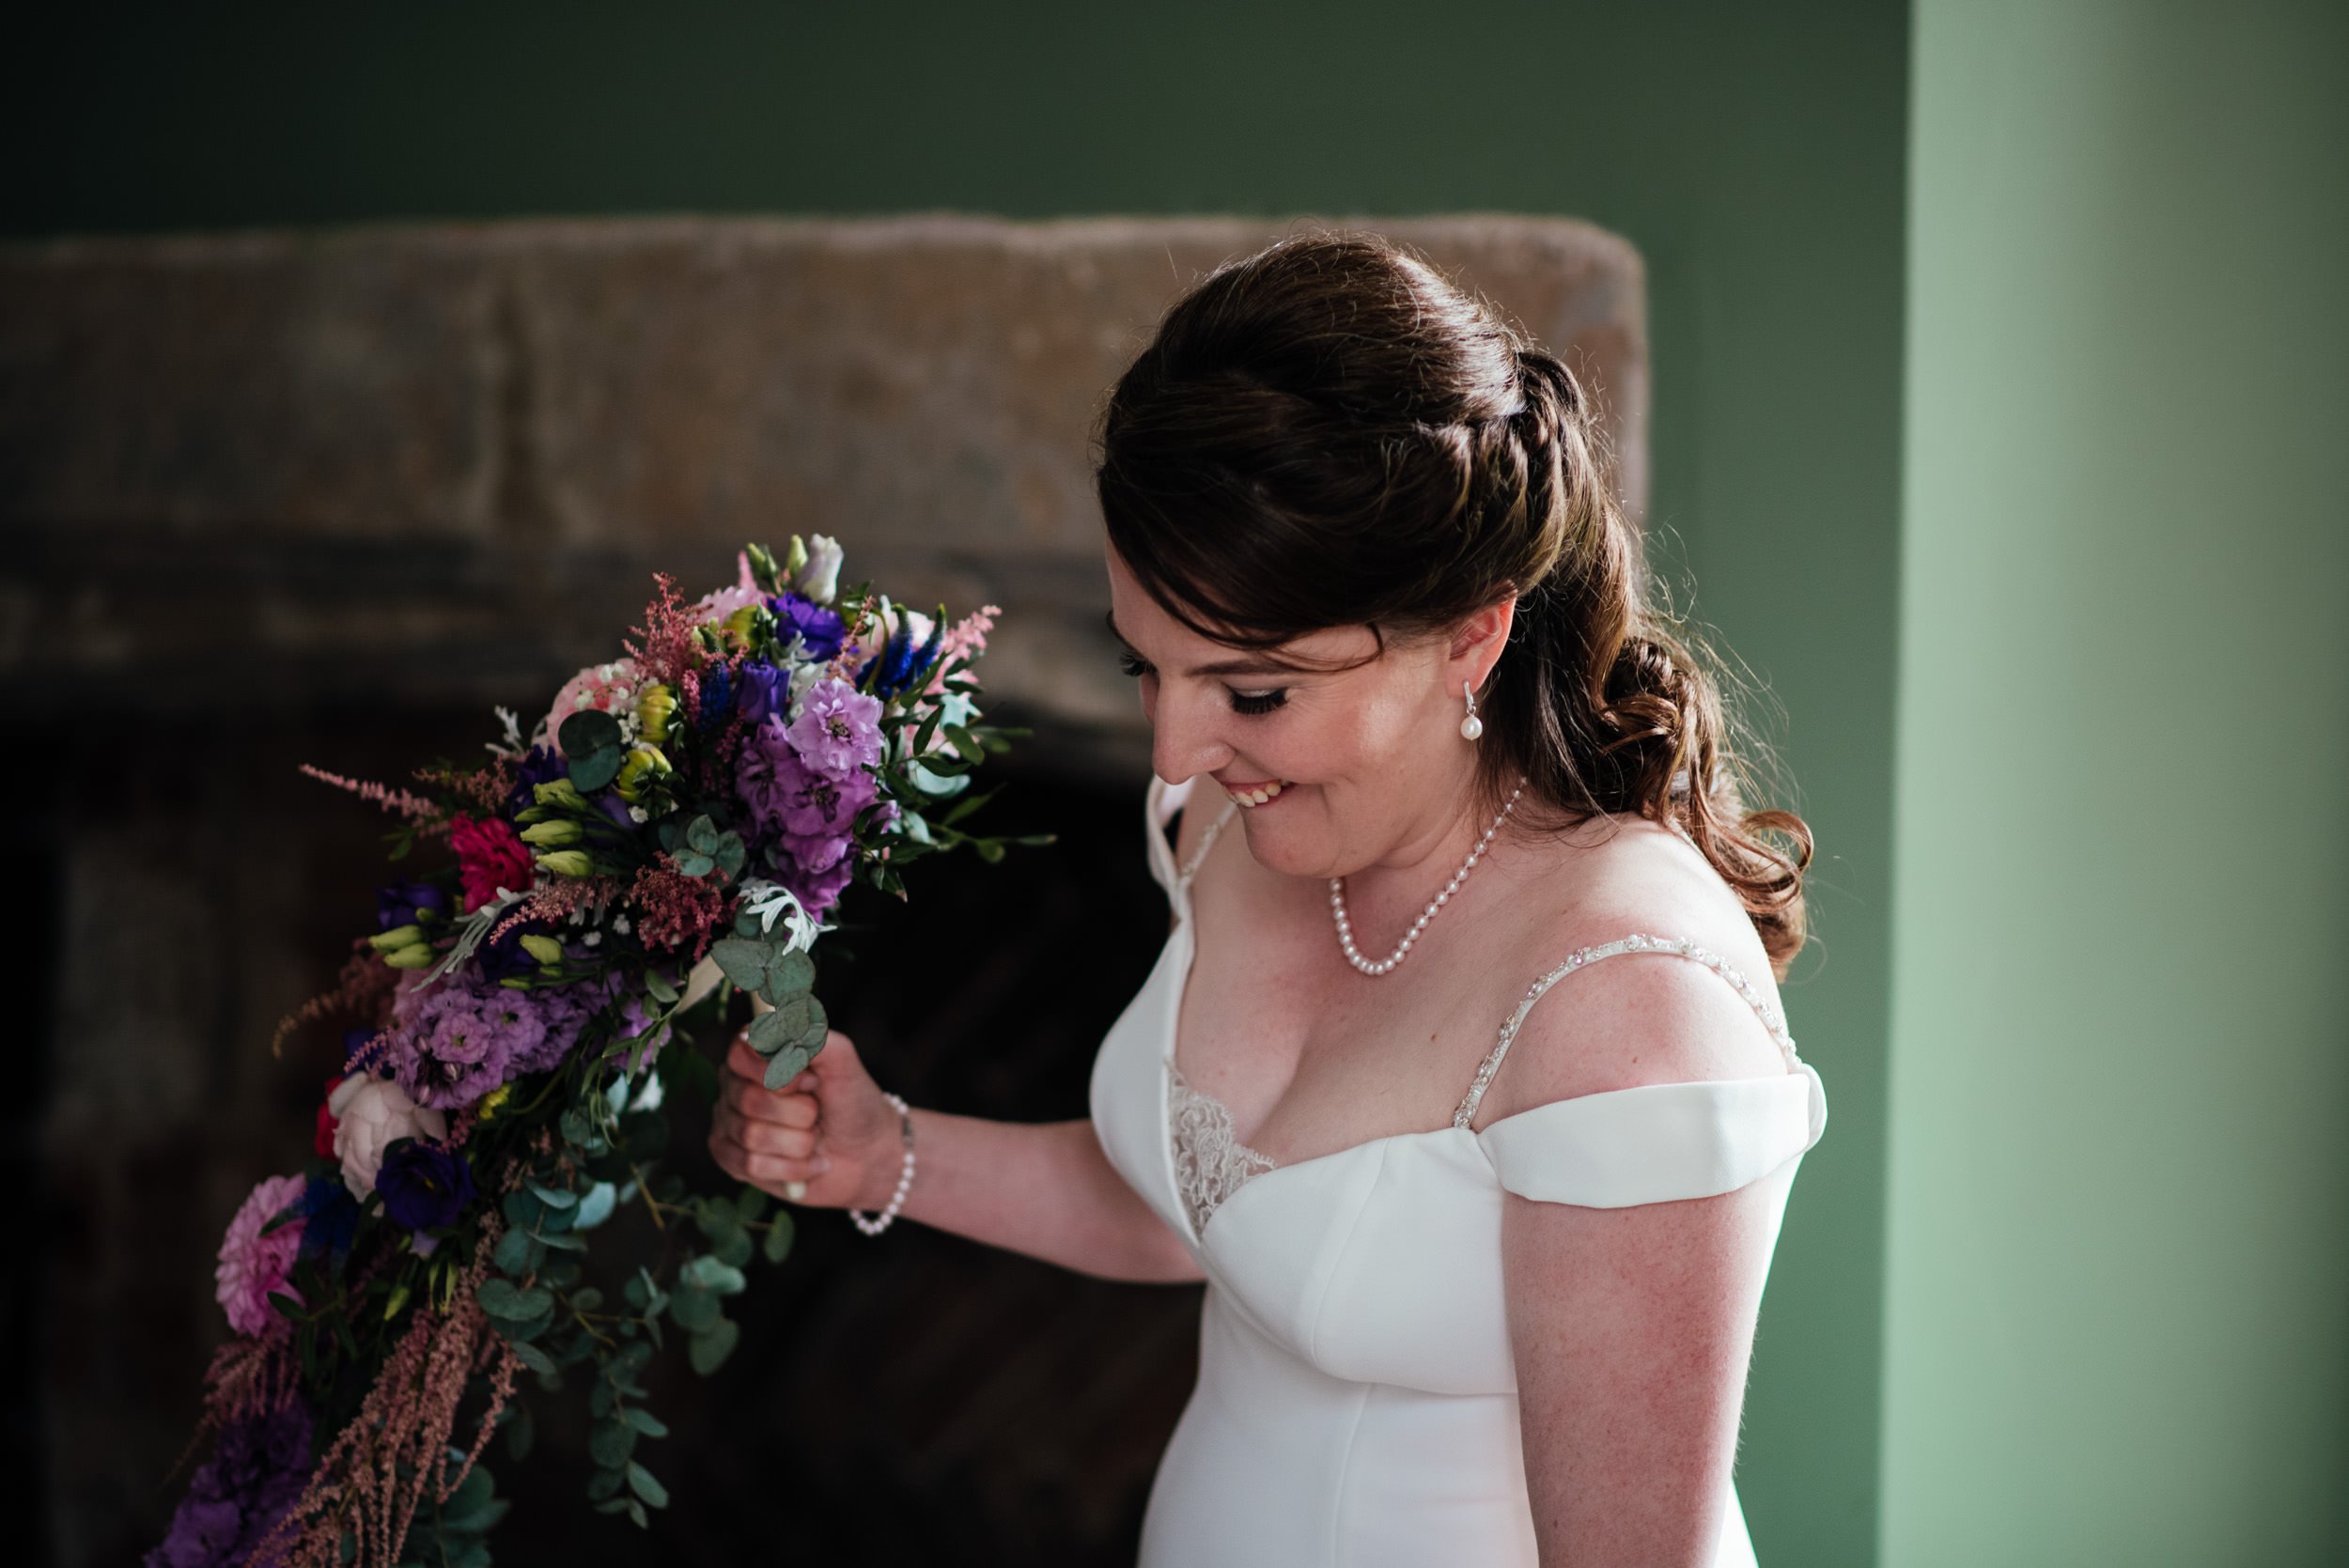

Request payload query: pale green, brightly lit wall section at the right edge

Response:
[1884,0,2349,1568]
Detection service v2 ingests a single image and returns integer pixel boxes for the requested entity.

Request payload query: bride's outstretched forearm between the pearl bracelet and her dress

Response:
[905,1110,1201,1281]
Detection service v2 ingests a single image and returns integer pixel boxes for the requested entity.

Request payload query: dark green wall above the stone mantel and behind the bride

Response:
[13,0,1910,1566]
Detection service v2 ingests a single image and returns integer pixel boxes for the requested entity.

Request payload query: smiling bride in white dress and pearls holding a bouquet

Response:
[709,235,1826,1568]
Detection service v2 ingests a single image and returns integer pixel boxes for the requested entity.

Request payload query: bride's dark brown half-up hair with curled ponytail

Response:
[1097,235,1812,971]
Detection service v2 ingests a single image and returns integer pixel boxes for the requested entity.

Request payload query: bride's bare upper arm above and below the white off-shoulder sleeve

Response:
[1480,955,1790,1568]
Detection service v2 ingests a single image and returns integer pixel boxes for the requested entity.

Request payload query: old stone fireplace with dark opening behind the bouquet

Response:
[0,218,1647,1563]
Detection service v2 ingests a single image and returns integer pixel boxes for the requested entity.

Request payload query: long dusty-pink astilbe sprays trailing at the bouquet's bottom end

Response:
[252,1220,520,1568]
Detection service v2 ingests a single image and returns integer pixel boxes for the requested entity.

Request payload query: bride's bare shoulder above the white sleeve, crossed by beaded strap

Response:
[1478,821,1788,1126]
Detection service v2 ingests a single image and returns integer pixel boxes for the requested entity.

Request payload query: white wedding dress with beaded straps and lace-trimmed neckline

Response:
[1093,780,1828,1568]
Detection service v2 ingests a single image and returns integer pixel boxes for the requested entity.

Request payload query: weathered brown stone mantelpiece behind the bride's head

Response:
[0,218,1647,766]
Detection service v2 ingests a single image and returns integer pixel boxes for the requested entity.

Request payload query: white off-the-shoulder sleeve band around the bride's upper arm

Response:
[1478,1063,1828,1209]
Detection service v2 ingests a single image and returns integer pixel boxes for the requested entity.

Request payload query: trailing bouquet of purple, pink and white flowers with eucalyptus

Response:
[148,536,1027,1568]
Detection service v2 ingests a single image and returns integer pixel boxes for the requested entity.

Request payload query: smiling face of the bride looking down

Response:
[1109,550,1513,877]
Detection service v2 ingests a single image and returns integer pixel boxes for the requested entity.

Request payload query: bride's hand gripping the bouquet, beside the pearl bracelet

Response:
[709,1031,905,1209]
